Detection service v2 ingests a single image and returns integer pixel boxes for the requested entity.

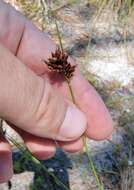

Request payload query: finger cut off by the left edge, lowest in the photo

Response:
[0,136,13,183]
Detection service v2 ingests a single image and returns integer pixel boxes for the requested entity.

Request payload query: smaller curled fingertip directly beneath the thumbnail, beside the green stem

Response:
[58,138,83,153]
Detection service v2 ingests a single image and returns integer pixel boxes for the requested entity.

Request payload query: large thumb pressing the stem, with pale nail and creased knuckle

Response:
[0,45,86,141]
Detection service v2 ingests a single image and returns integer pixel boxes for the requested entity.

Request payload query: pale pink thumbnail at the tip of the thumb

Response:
[59,105,87,140]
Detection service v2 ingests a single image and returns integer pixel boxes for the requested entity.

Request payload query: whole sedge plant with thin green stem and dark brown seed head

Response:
[44,5,104,190]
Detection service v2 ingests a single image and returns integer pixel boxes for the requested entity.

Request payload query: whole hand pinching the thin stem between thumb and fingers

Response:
[0,1,113,182]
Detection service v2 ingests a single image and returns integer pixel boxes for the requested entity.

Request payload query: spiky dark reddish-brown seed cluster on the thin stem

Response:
[44,47,76,81]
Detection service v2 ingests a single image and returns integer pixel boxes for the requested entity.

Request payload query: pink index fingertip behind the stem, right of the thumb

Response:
[68,69,113,140]
